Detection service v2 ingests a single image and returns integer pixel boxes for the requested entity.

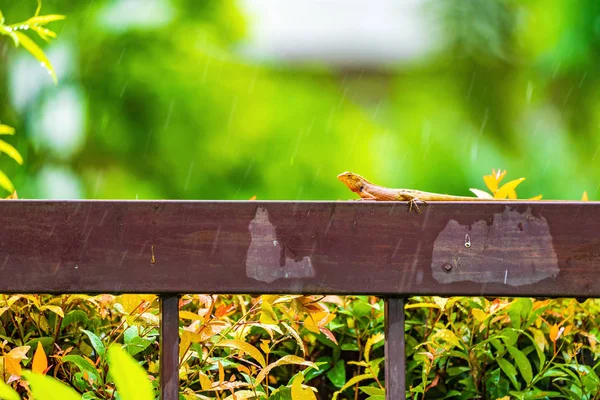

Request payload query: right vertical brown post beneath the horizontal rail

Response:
[385,297,406,400]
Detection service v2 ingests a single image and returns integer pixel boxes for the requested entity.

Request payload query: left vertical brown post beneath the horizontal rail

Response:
[159,294,179,400]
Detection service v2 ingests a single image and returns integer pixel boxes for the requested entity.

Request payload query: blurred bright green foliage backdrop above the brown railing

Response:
[0,0,600,200]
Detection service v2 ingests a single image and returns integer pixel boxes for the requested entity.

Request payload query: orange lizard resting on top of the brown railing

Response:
[338,172,486,214]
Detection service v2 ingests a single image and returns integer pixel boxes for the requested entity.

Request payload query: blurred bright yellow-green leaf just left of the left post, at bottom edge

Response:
[108,344,154,400]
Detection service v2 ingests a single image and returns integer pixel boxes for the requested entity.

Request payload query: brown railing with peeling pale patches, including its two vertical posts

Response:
[0,200,600,400]
